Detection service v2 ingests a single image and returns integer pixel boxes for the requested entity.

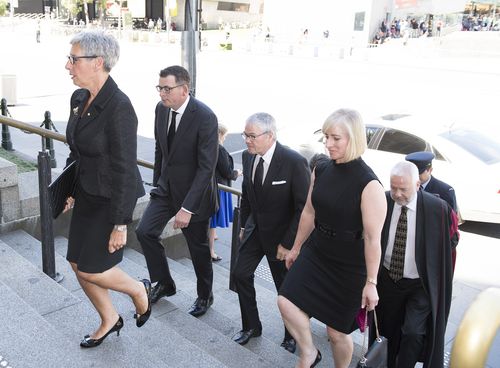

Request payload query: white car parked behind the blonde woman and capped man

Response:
[285,115,500,223]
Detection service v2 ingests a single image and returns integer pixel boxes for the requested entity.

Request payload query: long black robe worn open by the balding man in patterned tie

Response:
[380,191,452,367]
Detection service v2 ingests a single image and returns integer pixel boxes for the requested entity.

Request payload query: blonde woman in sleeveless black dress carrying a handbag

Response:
[278,109,387,368]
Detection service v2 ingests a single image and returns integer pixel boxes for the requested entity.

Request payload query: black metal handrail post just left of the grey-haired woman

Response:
[38,145,63,282]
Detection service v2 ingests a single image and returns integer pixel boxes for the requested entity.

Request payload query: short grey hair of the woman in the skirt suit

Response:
[69,30,120,73]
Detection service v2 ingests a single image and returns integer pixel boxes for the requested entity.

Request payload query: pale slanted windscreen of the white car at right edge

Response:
[441,129,500,165]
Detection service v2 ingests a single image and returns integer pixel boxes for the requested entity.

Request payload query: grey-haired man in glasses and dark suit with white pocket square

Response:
[233,112,310,353]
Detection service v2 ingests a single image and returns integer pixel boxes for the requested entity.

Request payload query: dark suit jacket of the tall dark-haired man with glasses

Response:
[151,96,219,222]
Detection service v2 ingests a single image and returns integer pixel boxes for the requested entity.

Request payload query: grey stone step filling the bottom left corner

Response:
[0,281,95,368]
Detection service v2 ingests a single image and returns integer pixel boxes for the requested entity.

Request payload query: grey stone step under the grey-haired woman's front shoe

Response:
[2,231,225,368]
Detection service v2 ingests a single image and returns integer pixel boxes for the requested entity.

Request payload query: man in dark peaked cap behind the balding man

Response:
[405,151,458,213]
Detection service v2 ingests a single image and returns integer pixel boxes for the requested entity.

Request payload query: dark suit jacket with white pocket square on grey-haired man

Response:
[241,142,311,255]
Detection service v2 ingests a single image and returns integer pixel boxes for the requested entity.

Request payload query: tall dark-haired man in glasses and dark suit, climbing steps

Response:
[136,66,219,317]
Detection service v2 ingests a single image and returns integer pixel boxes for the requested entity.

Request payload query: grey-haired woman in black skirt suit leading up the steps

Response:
[64,31,151,348]
